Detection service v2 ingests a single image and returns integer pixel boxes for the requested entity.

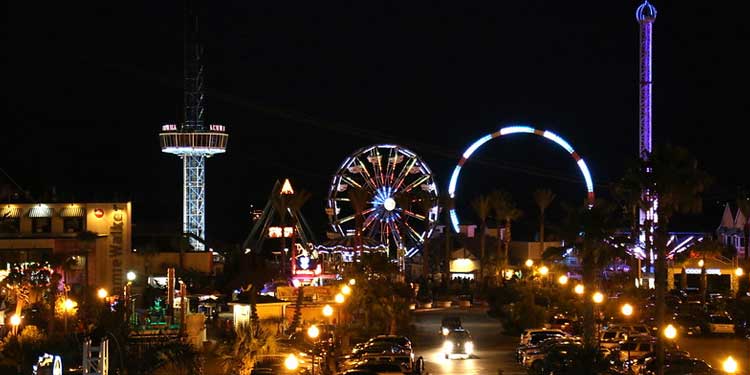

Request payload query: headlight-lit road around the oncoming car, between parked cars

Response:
[413,307,526,375]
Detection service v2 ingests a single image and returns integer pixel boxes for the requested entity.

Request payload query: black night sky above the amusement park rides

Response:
[7,1,750,241]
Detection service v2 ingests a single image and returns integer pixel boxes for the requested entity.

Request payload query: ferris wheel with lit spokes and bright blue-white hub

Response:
[326,145,438,257]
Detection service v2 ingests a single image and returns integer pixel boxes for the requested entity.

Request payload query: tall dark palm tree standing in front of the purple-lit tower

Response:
[638,145,711,369]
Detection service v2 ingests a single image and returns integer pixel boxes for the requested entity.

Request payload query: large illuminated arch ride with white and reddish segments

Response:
[448,126,594,232]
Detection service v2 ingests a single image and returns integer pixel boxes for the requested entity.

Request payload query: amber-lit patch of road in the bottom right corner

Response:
[677,336,750,374]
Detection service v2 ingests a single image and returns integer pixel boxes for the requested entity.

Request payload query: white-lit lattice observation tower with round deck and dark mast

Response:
[159,1,229,250]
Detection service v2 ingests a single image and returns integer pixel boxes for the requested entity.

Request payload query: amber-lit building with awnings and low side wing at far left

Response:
[0,202,213,294]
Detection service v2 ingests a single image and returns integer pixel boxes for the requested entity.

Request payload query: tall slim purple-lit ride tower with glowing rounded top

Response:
[635,0,658,262]
